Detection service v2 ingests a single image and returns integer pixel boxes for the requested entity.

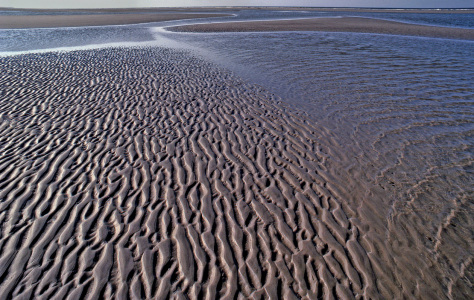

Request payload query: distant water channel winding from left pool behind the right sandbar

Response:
[0,10,474,53]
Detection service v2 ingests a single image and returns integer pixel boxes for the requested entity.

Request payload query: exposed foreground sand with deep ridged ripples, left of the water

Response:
[0,48,469,299]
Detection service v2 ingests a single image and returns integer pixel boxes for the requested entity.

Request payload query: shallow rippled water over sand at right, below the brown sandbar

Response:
[164,32,474,299]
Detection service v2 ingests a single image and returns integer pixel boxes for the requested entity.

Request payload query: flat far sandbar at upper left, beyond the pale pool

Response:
[0,13,229,29]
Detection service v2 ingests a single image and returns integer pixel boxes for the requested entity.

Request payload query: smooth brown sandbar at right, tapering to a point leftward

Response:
[169,17,474,40]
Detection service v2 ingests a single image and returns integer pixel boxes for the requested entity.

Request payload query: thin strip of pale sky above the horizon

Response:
[0,0,474,8]
